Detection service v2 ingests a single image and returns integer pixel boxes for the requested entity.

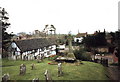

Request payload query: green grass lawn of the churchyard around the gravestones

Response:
[2,59,108,80]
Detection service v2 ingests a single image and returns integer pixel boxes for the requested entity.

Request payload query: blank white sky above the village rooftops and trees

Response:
[0,0,120,34]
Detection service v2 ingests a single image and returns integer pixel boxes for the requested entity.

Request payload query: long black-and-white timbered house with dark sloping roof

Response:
[8,38,56,60]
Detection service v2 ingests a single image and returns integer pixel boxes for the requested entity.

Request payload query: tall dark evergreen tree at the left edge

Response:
[0,7,13,57]
